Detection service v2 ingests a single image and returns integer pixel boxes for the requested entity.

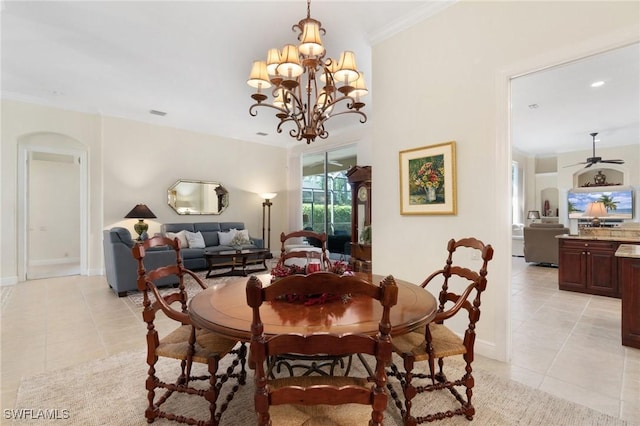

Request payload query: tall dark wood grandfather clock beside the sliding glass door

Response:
[347,166,371,272]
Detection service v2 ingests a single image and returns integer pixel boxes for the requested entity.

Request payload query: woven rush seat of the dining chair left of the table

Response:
[156,325,238,364]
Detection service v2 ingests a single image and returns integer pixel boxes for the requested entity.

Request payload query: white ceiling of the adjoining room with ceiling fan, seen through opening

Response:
[511,44,640,156]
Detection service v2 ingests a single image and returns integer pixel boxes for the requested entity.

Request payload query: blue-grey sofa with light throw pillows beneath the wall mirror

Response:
[161,222,264,271]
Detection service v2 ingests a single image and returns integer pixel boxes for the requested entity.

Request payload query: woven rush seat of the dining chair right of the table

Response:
[393,324,467,361]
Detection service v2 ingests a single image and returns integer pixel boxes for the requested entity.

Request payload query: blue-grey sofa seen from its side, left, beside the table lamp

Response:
[102,227,179,297]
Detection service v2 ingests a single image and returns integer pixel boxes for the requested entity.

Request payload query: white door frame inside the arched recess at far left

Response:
[17,143,89,281]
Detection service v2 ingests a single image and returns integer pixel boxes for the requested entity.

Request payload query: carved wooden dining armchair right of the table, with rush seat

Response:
[387,238,493,426]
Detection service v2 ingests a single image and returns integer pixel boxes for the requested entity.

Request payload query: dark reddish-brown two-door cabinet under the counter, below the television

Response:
[558,238,620,297]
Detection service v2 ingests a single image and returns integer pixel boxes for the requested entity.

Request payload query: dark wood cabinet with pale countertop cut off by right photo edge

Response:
[616,244,640,349]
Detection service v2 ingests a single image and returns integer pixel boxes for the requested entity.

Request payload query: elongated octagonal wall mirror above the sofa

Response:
[167,179,229,215]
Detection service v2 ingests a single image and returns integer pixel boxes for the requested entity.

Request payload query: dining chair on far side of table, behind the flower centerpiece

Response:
[278,230,331,270]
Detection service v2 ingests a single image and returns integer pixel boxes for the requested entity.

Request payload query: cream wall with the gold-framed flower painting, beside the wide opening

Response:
[372,1,640,359]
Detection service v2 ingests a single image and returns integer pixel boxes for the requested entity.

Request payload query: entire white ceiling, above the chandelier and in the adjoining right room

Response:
[1,0,640,155]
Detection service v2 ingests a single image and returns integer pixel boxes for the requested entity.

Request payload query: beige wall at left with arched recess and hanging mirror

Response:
[0,100,288,284]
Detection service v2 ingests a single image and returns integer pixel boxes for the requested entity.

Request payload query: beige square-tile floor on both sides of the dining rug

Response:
[0,257,640,424]
